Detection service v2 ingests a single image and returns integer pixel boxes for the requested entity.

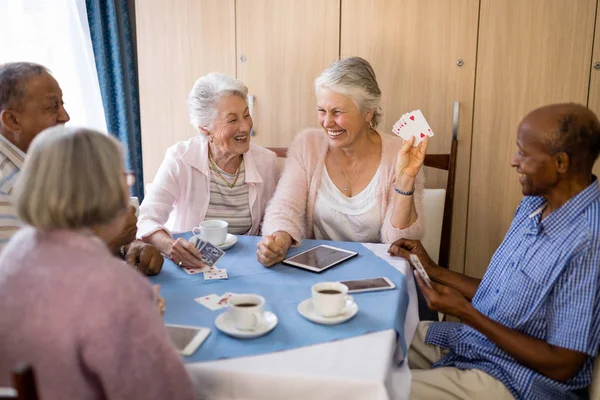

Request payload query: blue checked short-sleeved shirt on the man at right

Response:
[425,179,600,399]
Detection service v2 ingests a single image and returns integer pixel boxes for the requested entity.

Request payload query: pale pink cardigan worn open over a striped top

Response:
[137,137,279,238]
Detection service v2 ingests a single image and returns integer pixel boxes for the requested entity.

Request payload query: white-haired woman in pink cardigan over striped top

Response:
[138,73,279,268]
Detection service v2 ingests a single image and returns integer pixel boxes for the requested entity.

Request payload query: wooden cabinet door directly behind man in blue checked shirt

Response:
[459,0,596,277]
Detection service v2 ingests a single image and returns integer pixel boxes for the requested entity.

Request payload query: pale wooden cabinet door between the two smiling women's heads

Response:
[236,0,340,147]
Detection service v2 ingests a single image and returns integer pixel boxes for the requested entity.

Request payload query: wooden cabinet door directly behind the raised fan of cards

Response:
[341,0,479,271]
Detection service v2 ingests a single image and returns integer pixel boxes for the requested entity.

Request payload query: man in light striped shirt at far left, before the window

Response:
[0,62,163,275]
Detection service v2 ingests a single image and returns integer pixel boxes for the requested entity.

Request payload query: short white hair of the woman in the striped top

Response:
[187,72,248,139]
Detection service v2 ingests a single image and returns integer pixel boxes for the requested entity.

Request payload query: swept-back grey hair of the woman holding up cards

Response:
[315,57,382,128]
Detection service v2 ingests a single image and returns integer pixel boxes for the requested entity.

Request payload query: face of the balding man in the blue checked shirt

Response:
[511,114,560,196]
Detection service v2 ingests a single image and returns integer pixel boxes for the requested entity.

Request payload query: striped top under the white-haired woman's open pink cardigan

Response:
[205,165,252,235]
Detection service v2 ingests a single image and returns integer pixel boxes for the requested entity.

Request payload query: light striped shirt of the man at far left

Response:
[0,135,25,251]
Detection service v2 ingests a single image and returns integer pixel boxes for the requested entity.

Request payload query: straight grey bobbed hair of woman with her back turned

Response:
[15,125,129,230]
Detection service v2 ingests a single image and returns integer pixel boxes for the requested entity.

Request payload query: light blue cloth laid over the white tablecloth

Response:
[150,233,408,362]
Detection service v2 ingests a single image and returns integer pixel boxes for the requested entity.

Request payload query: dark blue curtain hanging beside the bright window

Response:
[85,0,144,201]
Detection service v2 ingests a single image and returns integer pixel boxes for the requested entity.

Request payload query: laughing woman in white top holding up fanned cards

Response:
[257,57,428,266]
